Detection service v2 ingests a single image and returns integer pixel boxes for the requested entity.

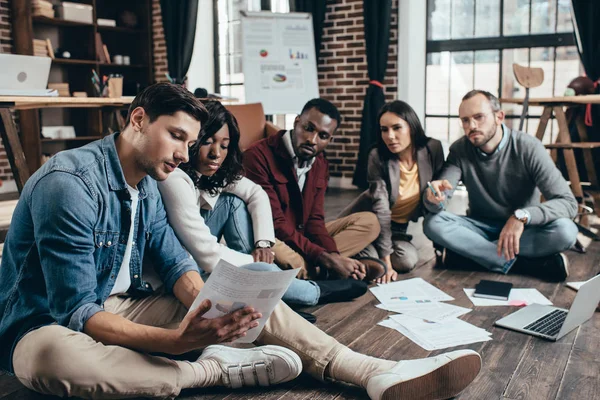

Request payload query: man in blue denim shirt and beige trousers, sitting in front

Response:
[0,84,481,399]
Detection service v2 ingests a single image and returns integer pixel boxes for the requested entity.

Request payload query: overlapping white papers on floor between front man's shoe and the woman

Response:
[371,278,492,351]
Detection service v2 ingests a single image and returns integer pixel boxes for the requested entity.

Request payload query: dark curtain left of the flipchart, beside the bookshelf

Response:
[160,0,198,84]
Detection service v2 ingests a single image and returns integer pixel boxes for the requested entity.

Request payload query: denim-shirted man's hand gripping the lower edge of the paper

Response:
[171,300,262,354]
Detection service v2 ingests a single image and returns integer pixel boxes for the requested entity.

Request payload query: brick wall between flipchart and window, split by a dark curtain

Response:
[318,0,398,182]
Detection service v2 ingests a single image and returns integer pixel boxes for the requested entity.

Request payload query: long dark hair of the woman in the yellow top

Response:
[377,100,429,159]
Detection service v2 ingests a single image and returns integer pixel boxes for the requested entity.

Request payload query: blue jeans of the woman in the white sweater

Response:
[200,193,321,306]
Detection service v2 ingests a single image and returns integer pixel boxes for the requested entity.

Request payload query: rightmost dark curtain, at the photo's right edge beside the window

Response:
[570,0,600,180]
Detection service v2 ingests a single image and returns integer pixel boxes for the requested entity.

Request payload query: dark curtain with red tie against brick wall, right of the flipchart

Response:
[352,0,392,189]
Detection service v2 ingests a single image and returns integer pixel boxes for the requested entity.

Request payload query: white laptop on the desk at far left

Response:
[0,54,58,96]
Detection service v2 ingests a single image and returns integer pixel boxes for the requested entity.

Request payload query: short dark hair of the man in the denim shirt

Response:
[125,82,208,125]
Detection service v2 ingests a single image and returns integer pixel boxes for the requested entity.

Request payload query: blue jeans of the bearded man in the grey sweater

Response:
[423,211,577,274]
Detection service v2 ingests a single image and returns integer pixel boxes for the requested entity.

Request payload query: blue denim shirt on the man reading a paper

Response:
[0,133,198,372]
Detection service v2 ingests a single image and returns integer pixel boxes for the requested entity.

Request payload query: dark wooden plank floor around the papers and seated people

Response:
[0,188,600,400]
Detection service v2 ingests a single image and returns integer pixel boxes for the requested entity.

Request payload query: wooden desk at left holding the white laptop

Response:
[0,96,134,193]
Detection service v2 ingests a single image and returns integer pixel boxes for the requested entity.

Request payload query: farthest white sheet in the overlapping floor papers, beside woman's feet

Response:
[371,278,454,306]
